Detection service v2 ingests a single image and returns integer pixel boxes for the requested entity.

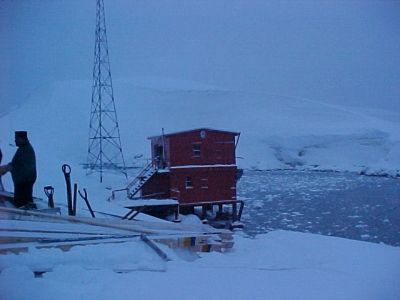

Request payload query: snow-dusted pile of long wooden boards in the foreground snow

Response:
[0,207,233,260]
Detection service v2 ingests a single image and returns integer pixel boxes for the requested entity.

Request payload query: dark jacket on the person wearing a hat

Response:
[10,141,36,183]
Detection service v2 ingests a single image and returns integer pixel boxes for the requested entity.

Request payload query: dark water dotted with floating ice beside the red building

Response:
[237,171,400,246]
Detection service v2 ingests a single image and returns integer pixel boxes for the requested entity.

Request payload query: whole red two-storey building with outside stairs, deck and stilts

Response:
[117,128,244,226]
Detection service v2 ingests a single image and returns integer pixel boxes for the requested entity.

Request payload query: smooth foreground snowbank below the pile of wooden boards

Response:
[0,231,400,300]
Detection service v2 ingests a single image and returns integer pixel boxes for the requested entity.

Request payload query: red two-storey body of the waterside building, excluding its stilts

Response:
[139,128,240,205]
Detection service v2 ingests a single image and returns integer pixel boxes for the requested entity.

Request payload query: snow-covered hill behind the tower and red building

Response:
[0,77,400,185]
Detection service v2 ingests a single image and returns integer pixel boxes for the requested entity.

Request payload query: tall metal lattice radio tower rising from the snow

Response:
[87,0,126,182]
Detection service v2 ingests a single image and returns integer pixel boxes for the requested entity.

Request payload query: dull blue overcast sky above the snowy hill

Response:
[0,0,400,111]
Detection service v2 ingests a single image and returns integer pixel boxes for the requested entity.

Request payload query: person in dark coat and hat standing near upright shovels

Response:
[0,131,37,208]
